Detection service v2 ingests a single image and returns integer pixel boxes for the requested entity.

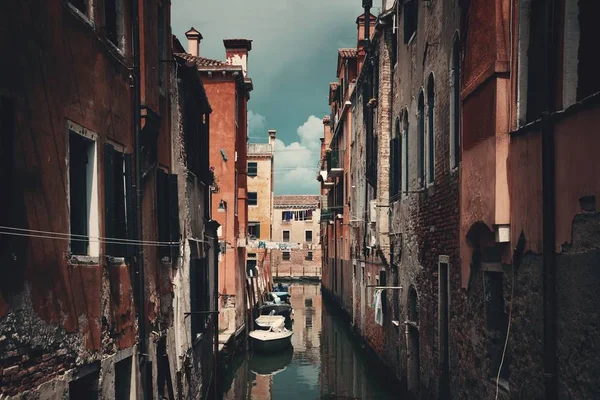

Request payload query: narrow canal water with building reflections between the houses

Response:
[219,283,400,400]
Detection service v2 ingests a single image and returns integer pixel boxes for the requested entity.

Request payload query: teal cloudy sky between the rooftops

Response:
[171,0,376,194]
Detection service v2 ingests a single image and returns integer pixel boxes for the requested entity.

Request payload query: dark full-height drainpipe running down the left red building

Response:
[131,0,152,399]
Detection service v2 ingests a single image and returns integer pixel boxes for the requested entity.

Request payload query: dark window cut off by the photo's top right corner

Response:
[577,0,600,100]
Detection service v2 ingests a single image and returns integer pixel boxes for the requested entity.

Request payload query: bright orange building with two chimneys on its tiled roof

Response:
[180,28,253,336]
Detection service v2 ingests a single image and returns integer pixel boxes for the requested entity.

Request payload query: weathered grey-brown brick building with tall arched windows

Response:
[384,1,460,398]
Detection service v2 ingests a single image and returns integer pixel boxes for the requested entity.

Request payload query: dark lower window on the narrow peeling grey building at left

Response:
[190,258,212,340]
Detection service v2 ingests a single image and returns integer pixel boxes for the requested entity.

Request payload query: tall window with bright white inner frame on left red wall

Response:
[69,131,99,256]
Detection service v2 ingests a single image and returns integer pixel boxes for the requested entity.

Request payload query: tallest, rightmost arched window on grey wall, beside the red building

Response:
[450,35,460,169]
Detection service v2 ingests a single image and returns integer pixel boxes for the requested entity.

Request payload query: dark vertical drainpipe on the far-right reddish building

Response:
[542,0,558,400]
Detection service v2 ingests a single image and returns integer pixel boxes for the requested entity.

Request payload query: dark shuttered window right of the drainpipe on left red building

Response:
[156,169,180,257]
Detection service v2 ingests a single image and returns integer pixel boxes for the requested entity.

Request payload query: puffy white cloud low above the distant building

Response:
[275,115,323,194]
